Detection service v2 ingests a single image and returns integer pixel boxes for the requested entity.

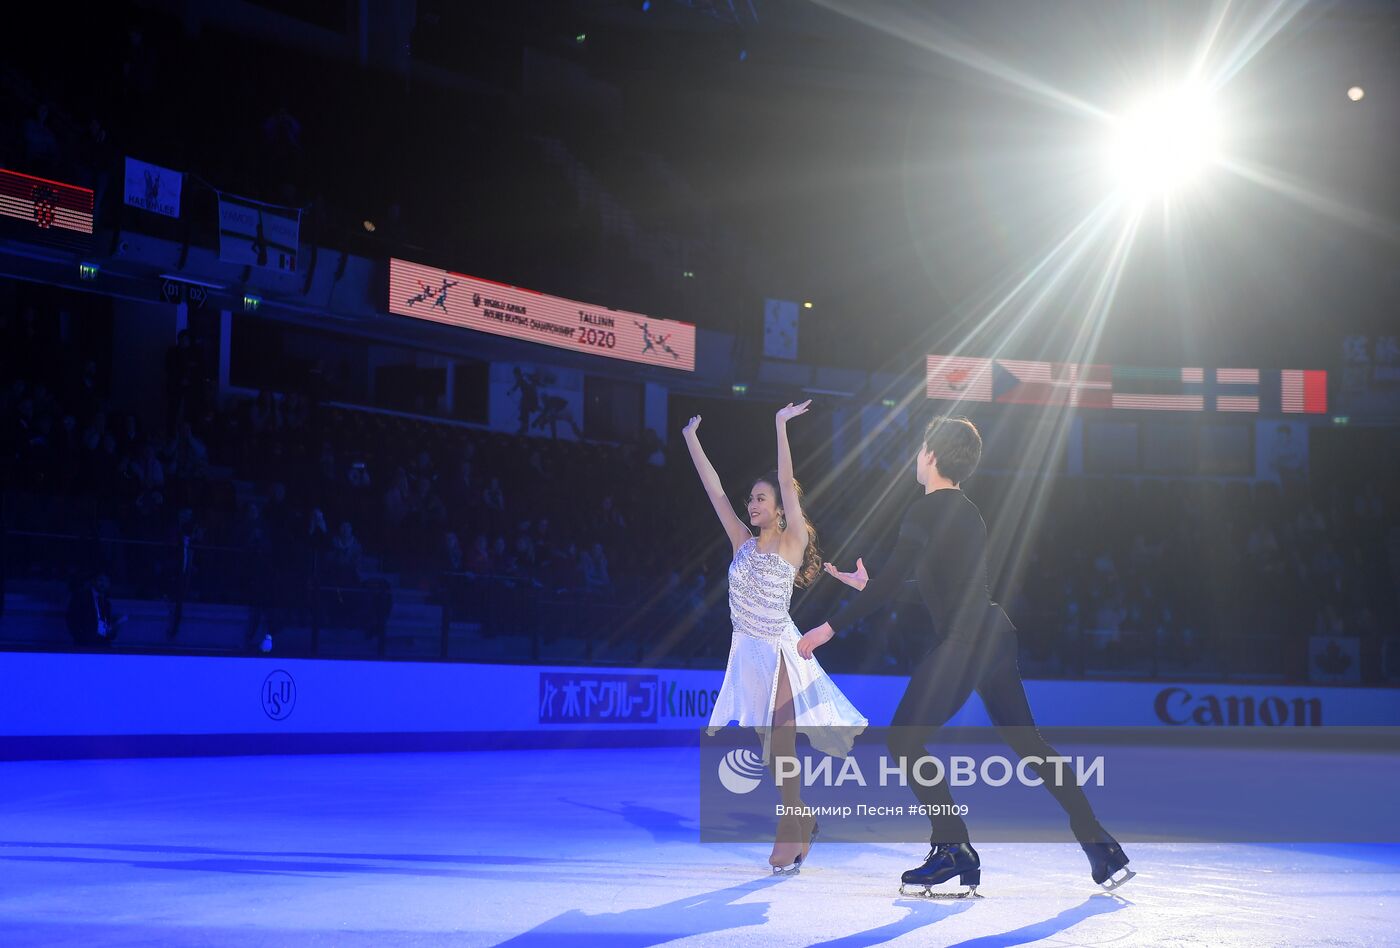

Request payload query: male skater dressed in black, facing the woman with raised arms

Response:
[798,416,1134,895]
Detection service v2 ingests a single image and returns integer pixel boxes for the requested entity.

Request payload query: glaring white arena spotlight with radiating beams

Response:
[1106,87,1219,199]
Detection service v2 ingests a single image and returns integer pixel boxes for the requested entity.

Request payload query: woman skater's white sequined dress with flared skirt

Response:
[707,538,869,762]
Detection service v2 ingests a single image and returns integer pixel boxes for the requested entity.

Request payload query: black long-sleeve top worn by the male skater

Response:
[829,489,1011,639]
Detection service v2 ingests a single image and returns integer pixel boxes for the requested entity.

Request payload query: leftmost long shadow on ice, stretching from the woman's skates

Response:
[500,875,785,948]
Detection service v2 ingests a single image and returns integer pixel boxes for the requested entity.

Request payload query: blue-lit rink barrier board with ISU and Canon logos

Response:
[0,653,1400,759]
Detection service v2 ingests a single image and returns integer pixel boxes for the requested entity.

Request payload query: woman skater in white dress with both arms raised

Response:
[685,399,868,872]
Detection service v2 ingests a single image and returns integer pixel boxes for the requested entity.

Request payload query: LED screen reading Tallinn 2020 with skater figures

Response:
[389,259,696,372]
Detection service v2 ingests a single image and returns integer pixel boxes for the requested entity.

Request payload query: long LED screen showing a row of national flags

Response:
[927,356,1327,414]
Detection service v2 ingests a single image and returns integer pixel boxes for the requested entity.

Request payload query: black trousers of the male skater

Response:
[888,608,1105,844]
